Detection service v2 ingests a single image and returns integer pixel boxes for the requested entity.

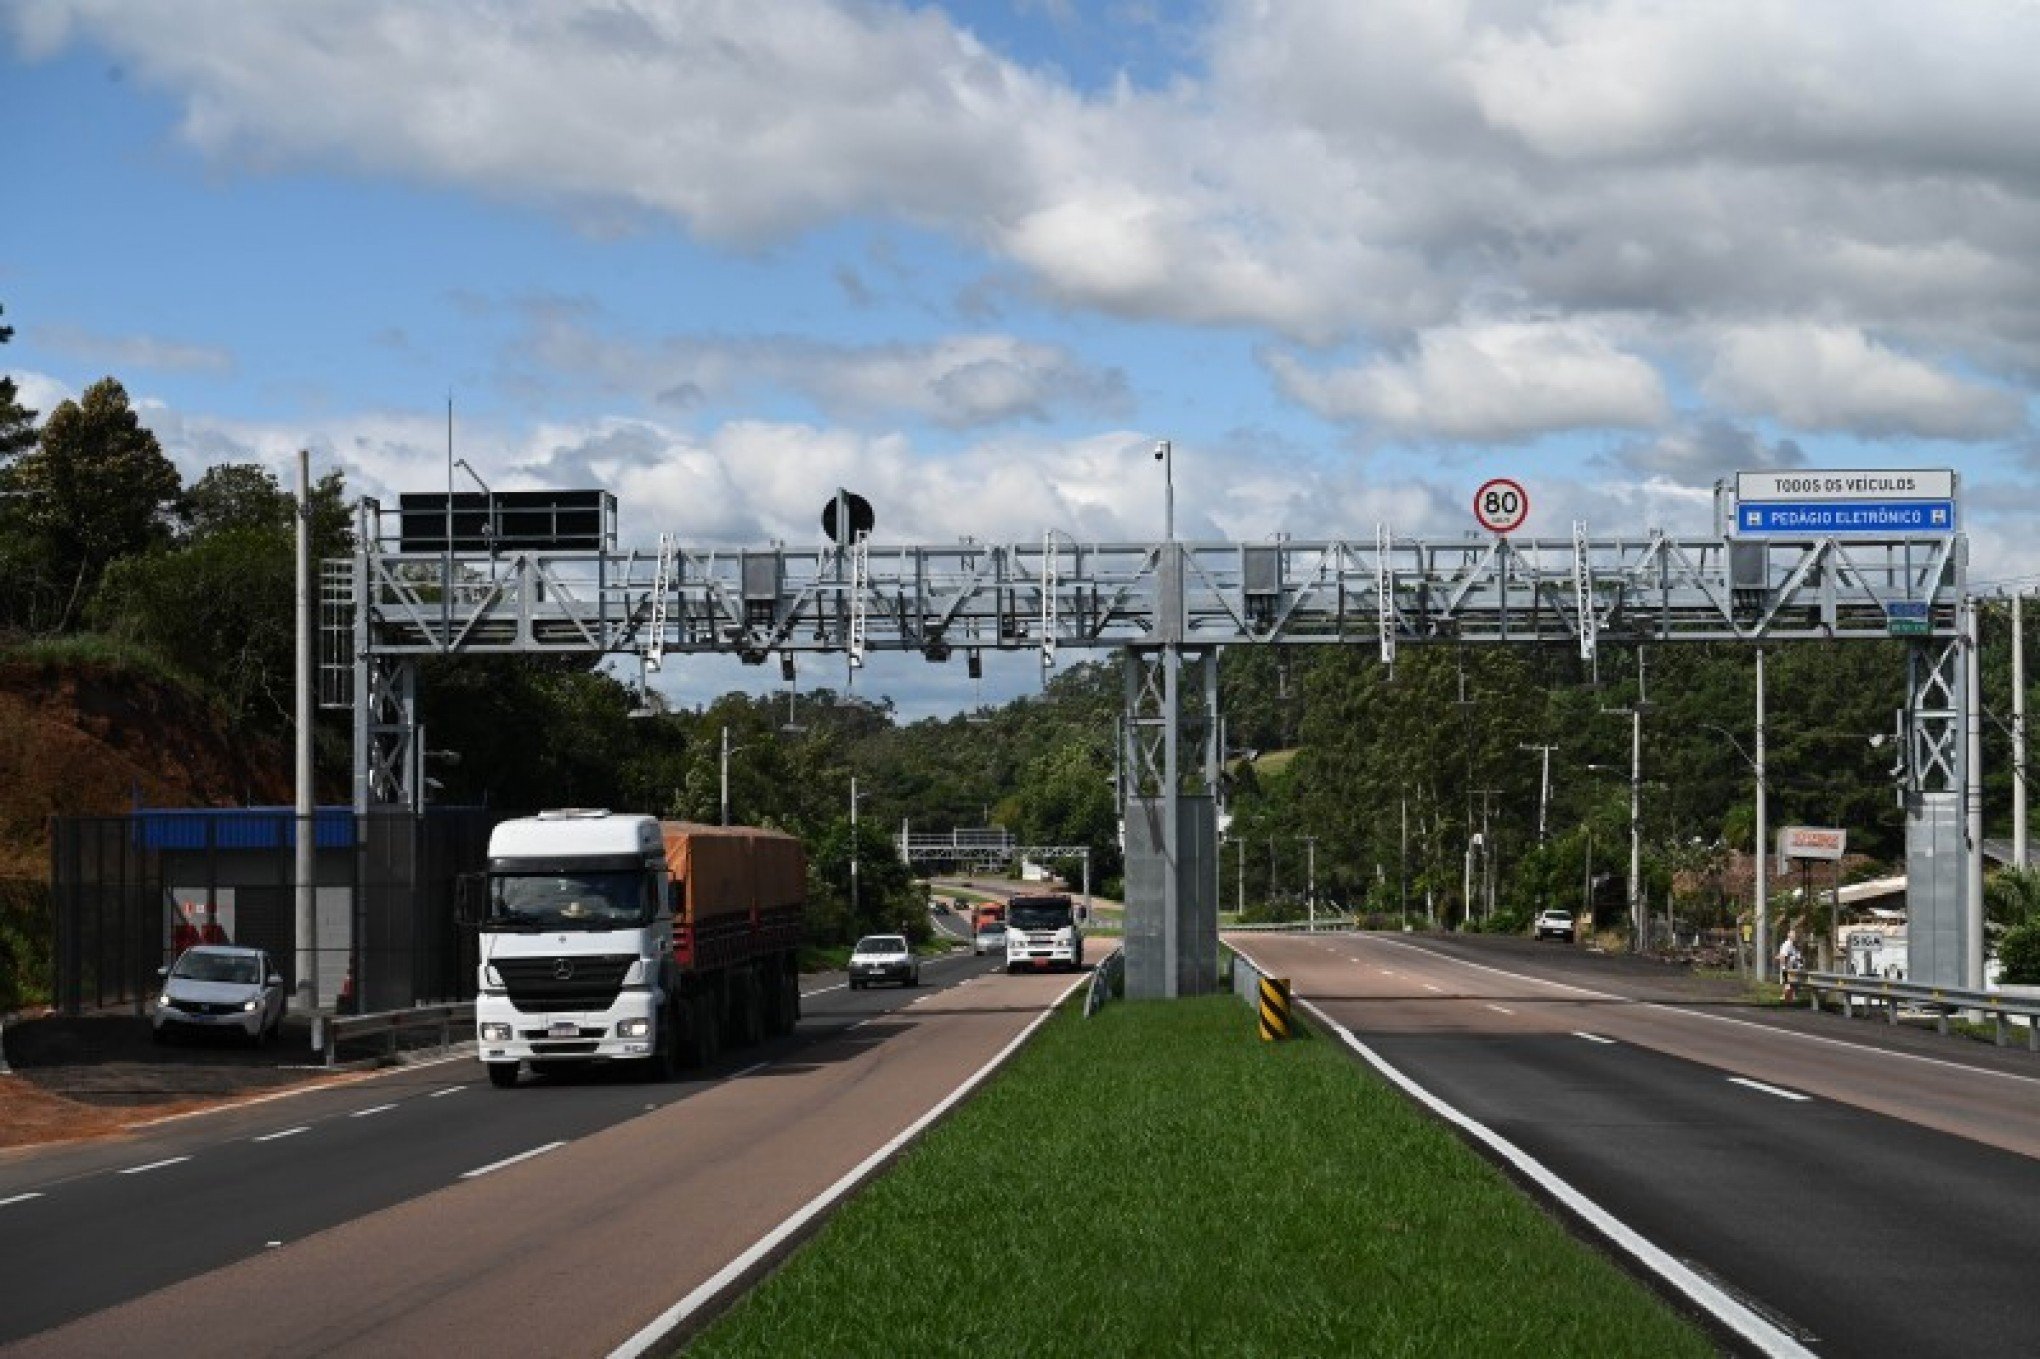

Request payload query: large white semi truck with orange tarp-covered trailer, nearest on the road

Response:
[463,808,808,1086]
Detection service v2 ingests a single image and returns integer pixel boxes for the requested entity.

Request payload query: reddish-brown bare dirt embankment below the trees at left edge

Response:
[0,659,292,877]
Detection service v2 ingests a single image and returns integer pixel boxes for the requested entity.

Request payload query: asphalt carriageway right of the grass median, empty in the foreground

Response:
[1238,935,2040,1355]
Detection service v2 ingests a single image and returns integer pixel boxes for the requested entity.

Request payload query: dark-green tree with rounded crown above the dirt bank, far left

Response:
[6,378,182,633]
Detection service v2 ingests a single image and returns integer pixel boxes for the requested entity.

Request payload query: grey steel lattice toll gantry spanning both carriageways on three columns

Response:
[322,502,1983,996]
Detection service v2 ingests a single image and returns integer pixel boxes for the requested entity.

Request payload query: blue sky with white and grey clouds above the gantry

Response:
[0,0,2040,716]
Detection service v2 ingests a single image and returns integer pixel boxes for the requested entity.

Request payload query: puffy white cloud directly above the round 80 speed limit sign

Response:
[1269,322,1667,441]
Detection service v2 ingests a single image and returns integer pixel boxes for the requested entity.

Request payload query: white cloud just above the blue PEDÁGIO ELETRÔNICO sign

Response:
[1705,324,2026,439]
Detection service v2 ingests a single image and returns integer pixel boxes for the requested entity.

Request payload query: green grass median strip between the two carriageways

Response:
[687,996,1714,1357]
